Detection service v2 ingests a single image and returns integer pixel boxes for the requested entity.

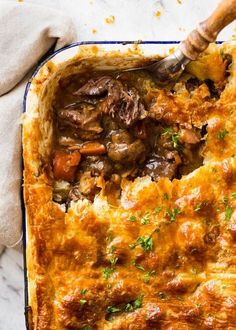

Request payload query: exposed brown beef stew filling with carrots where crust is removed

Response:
[52,72,206,205]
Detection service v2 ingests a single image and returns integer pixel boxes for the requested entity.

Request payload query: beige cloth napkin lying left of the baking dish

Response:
[0,1,75,246]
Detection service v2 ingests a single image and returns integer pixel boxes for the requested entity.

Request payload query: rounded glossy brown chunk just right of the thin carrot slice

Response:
[107,130,146,164]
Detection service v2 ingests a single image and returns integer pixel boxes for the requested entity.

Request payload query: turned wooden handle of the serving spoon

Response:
[180,0,236,60]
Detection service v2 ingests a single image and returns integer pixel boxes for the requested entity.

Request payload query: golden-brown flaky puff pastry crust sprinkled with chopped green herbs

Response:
[23,43,236,330]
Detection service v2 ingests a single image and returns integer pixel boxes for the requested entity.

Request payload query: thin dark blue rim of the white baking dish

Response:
[21,40,223,330]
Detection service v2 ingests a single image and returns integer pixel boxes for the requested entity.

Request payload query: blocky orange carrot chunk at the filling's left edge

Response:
[53,150,81,181]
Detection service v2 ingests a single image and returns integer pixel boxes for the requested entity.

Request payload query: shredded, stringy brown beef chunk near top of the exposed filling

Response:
[74,76,146,126]
